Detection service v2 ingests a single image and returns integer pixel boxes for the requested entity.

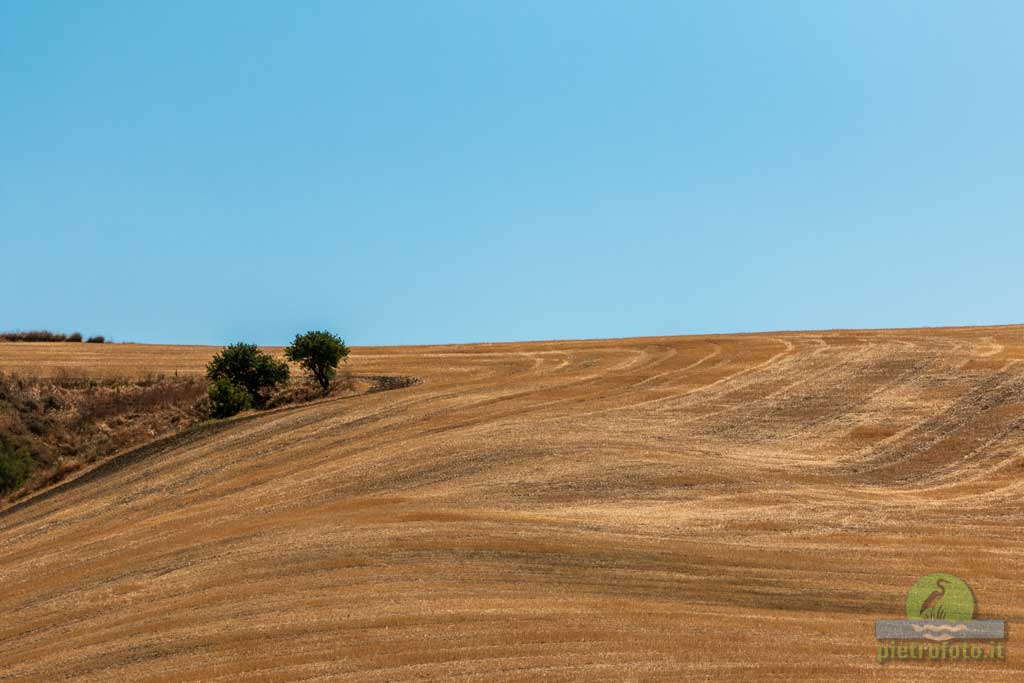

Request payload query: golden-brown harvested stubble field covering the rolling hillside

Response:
[0,327,1024,681]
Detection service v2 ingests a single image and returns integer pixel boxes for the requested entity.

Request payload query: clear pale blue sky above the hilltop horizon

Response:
[0,0,1024,344]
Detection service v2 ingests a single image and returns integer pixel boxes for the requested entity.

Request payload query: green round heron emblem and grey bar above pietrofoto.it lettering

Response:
[874,572,1006,642]
